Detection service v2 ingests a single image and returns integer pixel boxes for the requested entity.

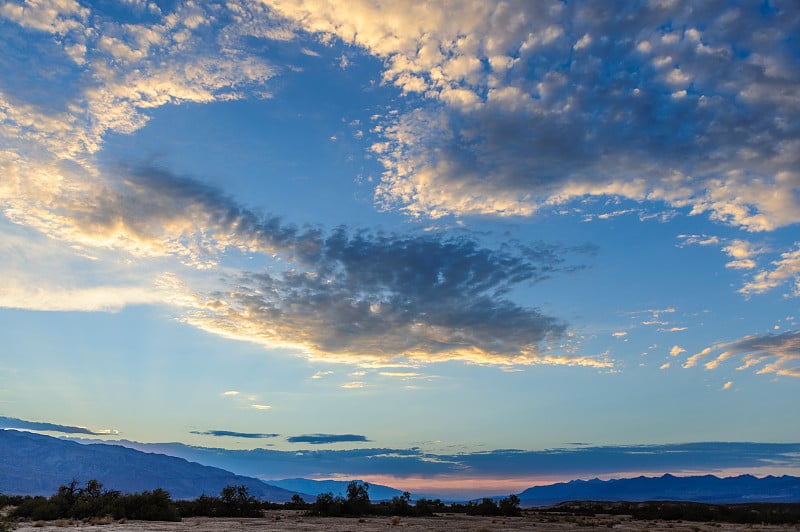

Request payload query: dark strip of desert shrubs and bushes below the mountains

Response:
[0,480,800,532]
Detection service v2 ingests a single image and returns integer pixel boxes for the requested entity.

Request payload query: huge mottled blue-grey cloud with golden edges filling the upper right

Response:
[266,0,800,235]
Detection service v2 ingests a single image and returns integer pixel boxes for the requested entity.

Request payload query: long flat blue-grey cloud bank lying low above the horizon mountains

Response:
[103,435,800,481]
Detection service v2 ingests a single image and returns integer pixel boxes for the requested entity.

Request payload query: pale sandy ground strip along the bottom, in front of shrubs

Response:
[12,510,800,532]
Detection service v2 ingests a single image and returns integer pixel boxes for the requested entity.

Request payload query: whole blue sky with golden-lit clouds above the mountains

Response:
[0,0,800,489]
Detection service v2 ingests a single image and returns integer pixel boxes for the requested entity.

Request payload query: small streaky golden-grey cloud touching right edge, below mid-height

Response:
[683,331,800,377]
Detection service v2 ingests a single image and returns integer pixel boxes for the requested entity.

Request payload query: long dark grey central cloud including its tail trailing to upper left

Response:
[90,168,592,367]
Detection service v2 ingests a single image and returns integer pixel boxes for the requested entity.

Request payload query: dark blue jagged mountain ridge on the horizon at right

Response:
[518,474,800,506]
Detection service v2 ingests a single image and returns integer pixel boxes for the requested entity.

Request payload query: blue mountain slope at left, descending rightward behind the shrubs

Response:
[0,429,295,502]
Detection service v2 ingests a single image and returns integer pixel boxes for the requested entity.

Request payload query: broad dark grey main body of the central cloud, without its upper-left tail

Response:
[203,222,568,363]
